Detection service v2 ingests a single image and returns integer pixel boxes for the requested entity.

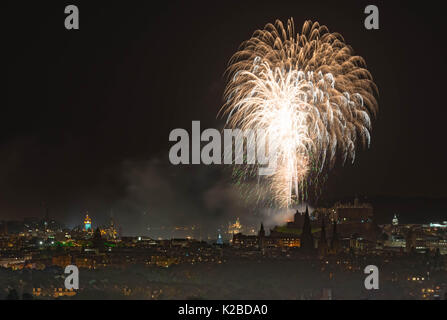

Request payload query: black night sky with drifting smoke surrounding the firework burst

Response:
[6,0,447,233]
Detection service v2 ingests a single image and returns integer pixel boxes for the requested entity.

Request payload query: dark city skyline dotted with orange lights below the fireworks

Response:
[0,194,447,300]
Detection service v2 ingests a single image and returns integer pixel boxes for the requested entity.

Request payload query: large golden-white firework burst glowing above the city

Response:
[221,19,378,207]
